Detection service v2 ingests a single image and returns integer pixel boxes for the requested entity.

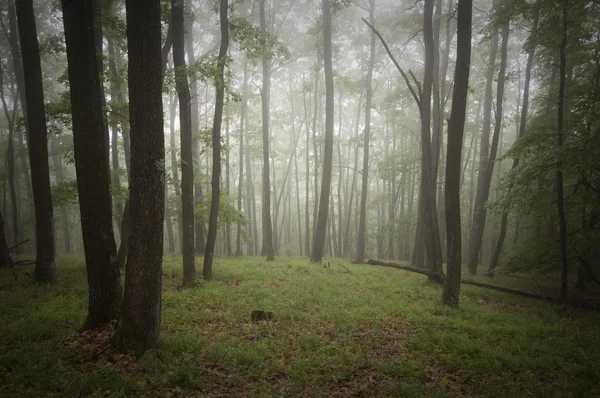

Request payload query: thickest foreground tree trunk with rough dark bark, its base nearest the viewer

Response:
[117,0,165,353]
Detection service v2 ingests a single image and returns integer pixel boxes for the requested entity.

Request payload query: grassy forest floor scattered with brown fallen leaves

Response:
[0,256,600,397]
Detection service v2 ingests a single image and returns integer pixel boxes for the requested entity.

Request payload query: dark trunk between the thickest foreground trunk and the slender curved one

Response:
[171,0,196,285]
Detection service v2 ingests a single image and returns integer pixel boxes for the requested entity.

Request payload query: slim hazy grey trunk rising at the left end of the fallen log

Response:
[355,0,375,264]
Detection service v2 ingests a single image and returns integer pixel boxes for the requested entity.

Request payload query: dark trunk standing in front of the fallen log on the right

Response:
[442,0,473,306]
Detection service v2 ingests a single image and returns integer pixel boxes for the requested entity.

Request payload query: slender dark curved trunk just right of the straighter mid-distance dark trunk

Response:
[202,0,229,280]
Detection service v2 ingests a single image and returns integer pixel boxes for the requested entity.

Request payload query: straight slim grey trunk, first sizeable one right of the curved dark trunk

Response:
[260,0,275,261]
